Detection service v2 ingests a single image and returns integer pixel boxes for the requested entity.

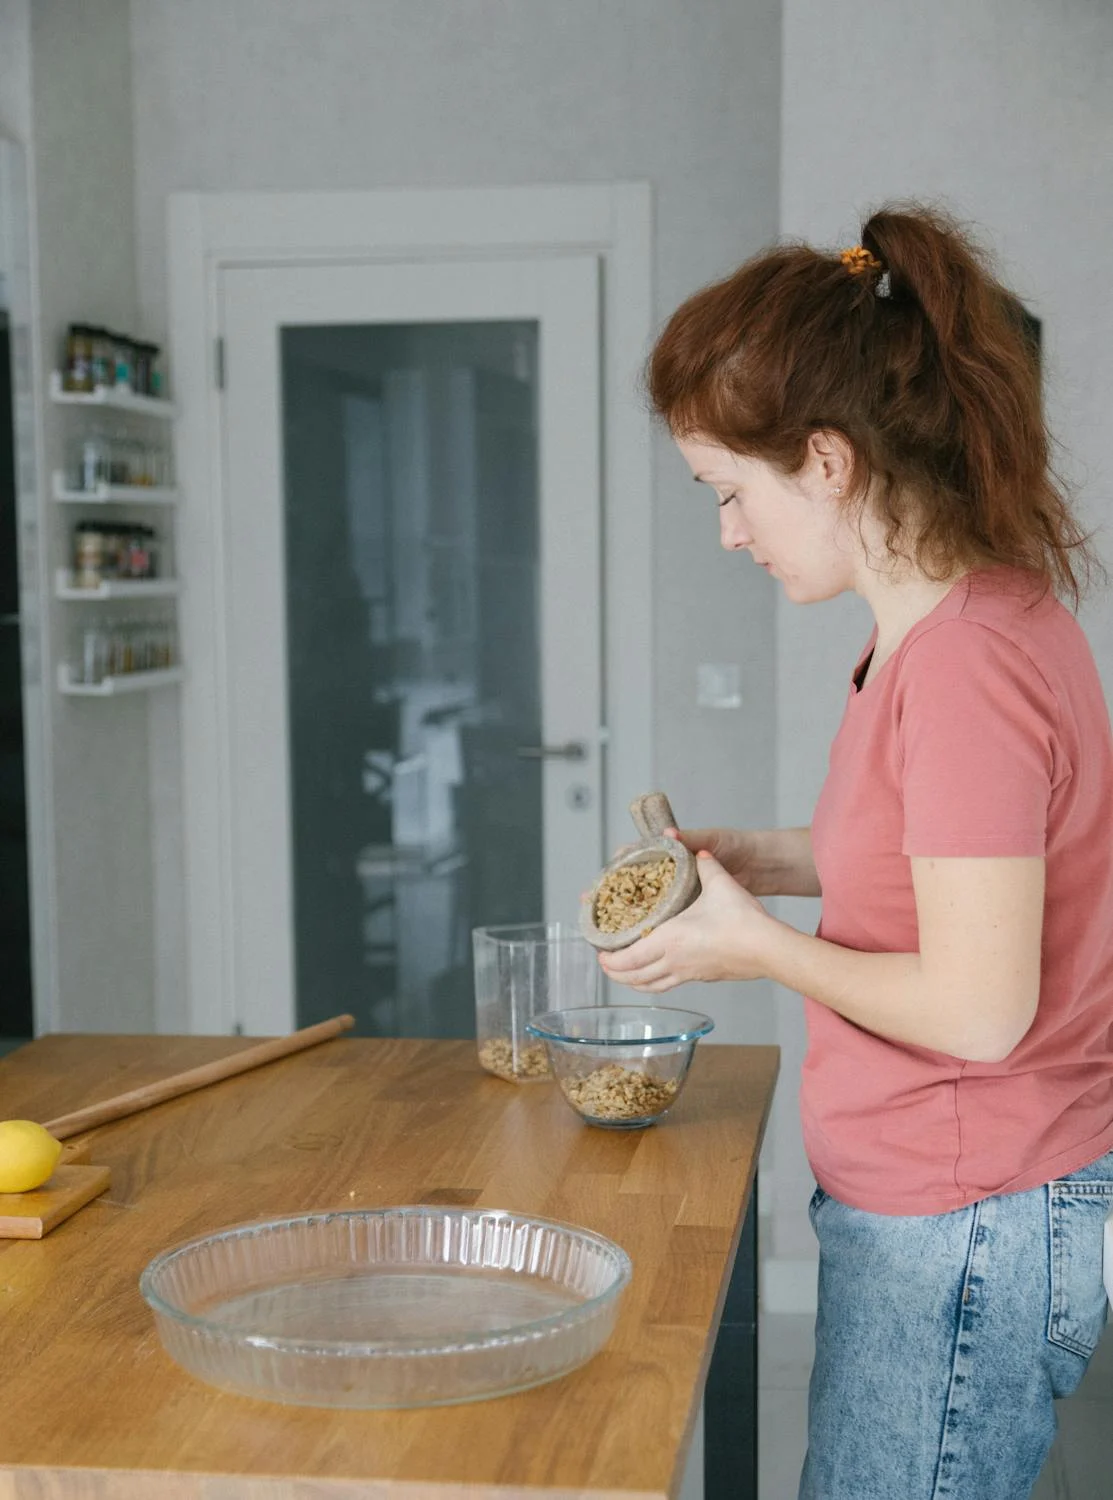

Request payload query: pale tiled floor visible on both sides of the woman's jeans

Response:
[758,1313,1113,1500]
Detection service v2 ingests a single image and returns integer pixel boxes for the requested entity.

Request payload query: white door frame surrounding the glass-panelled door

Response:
[168,183,653,1034]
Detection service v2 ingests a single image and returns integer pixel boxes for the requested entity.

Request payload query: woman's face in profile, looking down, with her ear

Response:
[677,438,861,605]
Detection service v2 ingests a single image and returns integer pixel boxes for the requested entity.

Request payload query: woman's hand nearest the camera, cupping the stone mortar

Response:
[599,851,776,995]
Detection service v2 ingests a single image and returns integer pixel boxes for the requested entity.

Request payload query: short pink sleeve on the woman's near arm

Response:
[894,620,1059,857]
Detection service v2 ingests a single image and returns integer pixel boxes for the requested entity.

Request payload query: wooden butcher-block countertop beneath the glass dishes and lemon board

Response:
[0,1035,779,1500]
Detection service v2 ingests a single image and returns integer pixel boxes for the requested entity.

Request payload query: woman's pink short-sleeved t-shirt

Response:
[801,570,1113,1214]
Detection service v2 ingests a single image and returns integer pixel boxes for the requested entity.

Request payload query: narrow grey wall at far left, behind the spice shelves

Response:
[0,0,153,1031]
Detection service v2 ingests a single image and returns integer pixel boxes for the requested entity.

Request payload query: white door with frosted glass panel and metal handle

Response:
[219,255,603,1035]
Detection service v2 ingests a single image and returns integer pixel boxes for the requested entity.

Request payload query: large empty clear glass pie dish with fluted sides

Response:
[140,1208,630,1409]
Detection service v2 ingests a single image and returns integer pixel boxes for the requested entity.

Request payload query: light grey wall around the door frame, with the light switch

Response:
[132,0,780,1040]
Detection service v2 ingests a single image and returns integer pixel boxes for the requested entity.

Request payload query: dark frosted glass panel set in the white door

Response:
[281,321,543,1037]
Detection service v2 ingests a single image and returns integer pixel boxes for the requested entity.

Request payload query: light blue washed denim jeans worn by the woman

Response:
[800,1152,1113,1500]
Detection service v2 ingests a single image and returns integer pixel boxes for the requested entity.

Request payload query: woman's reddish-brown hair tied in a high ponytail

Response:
[647,204,1100,608]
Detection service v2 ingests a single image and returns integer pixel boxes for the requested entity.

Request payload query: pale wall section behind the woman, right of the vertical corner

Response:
[774,0,1113,1286]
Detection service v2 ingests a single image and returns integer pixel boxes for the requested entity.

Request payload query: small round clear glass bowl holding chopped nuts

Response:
[527,1005,716,1130]
